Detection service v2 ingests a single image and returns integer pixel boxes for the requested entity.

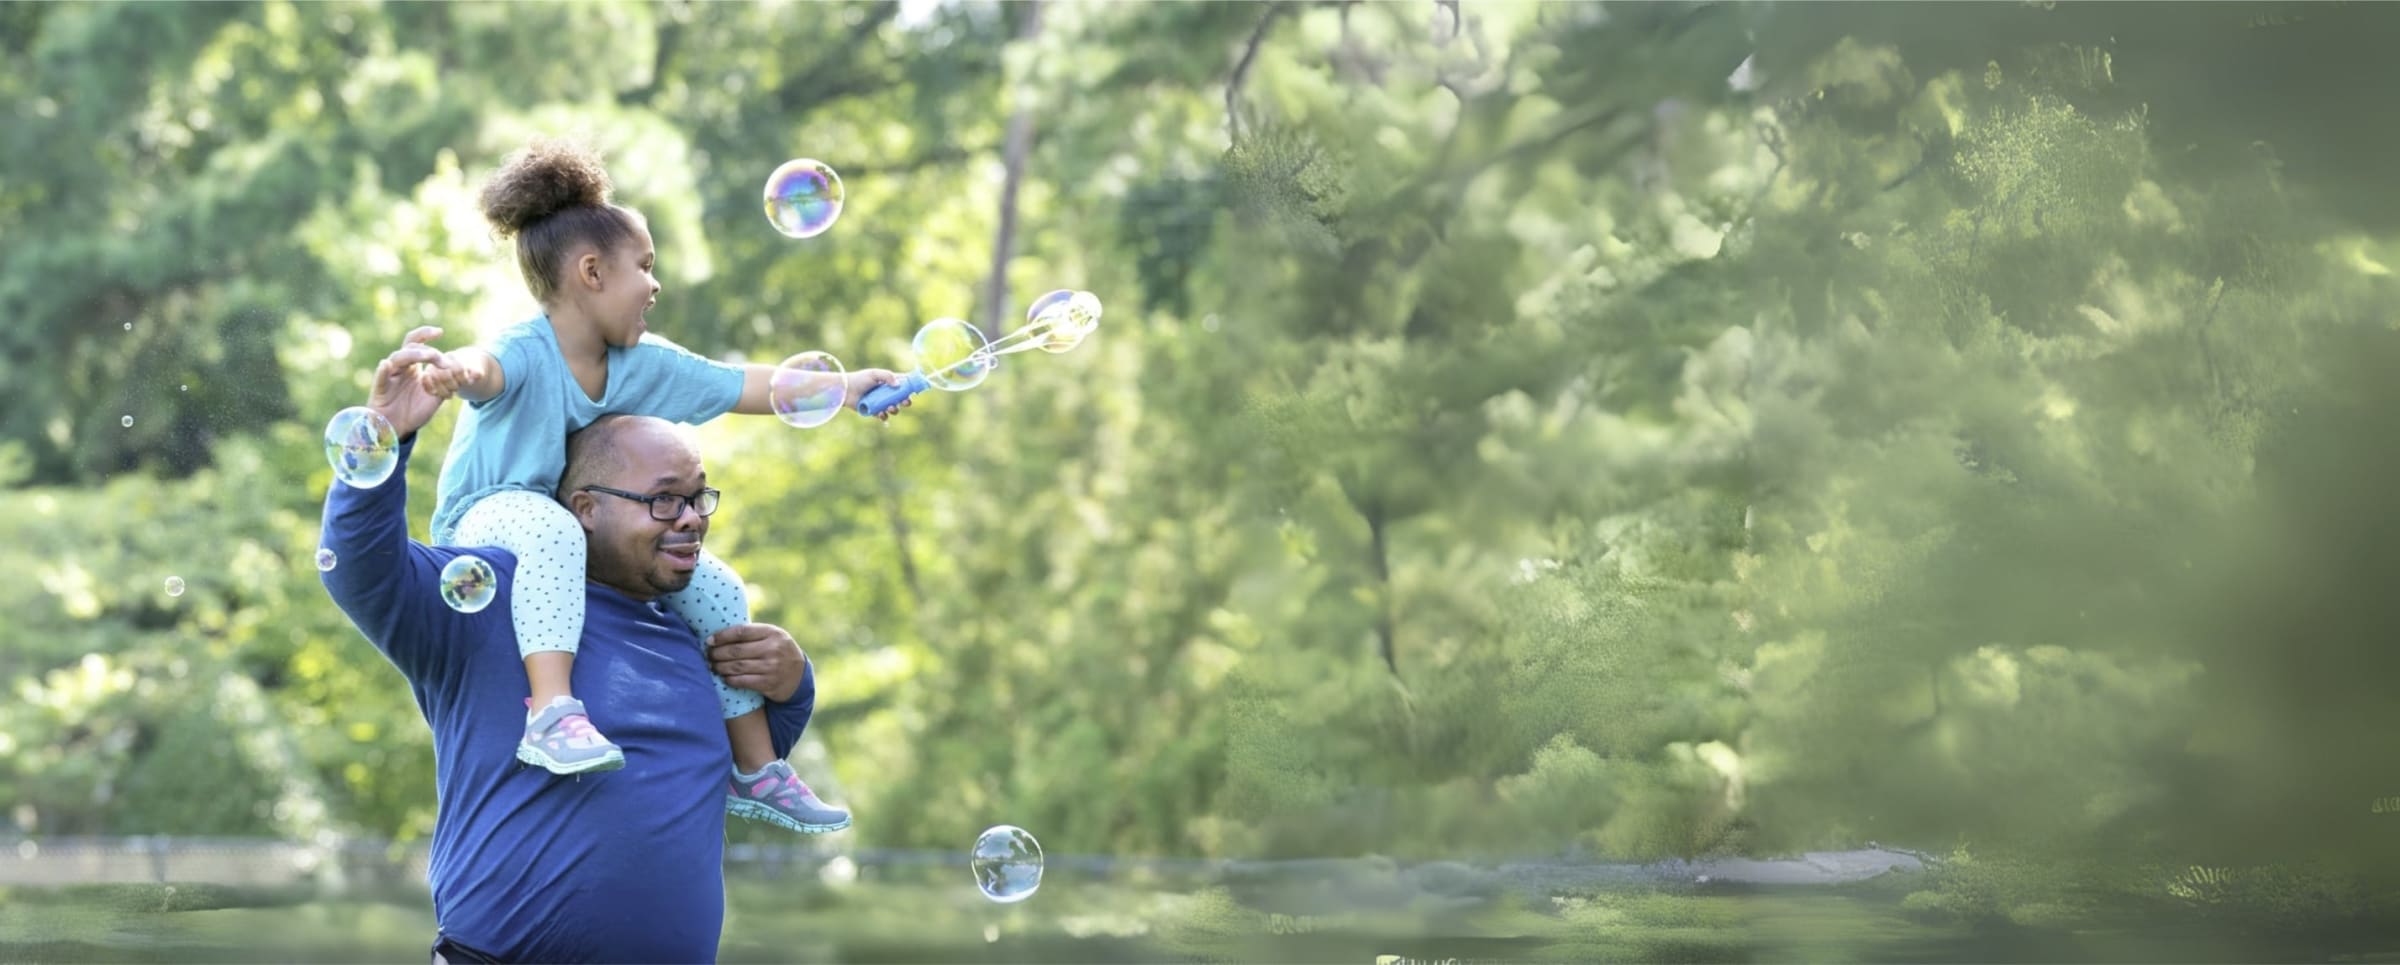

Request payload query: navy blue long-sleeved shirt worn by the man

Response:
[324,439,816,963]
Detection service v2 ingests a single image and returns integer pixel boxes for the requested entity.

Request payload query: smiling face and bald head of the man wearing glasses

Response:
[576,425,708,600]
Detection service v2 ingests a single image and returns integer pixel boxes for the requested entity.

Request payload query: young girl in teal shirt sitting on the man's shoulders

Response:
[418,142,898,833]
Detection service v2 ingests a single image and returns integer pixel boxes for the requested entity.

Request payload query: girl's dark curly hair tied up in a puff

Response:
[478,139,641,302]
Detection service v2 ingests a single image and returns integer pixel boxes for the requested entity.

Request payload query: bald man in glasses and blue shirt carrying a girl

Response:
[324,343,840,963]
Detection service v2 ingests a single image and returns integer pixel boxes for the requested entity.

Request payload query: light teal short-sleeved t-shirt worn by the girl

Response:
[432,317,746,545]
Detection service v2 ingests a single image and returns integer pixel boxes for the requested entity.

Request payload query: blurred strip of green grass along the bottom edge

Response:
[14,869,2400,963]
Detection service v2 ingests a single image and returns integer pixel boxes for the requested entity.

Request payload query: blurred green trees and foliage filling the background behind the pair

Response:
[14,0,2400,955]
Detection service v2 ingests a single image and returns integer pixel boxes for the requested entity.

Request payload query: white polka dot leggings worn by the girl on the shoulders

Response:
[451,490,766,718]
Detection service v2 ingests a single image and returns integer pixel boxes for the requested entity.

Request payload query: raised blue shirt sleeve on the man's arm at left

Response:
[319,437,509,682]
